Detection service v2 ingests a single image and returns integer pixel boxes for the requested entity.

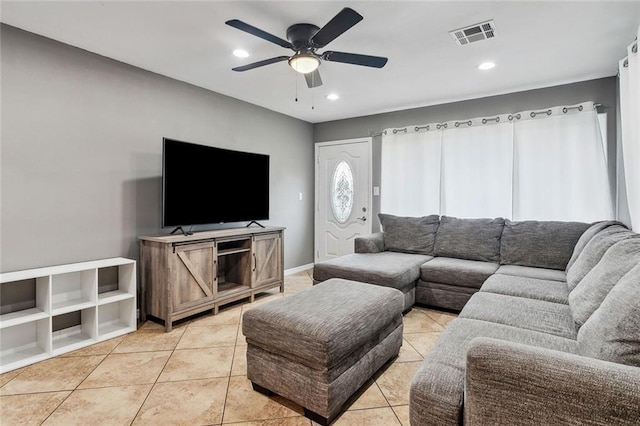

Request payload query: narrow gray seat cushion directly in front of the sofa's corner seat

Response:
[480,274,569,304]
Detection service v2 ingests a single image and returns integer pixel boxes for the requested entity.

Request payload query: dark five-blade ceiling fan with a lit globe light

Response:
[226,7,387,88]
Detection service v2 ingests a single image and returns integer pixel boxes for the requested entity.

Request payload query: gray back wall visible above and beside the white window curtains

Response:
[314,77,624,231]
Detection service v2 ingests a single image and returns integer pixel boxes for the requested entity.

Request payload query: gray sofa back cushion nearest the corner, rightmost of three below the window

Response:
[500,220,589,271]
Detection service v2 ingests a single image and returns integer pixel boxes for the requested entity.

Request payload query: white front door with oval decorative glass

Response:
[315,138,371,263]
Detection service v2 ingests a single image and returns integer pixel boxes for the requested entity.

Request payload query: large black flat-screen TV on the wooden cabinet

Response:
[162,138,269,227]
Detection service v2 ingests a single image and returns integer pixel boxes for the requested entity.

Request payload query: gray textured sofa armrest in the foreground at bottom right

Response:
[464,337,640,425]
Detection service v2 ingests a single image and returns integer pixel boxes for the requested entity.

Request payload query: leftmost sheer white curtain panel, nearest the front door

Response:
[380,125,442,216]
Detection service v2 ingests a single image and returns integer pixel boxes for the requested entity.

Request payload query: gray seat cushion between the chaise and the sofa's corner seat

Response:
[420,257,500,288]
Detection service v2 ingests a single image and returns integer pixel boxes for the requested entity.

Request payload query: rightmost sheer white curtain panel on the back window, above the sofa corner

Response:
[513,102,614,222]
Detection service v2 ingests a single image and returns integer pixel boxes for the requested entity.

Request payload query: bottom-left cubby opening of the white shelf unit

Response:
[0,317,51,373]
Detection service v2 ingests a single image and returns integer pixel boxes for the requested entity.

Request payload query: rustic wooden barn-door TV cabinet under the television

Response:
[140,227,284,331]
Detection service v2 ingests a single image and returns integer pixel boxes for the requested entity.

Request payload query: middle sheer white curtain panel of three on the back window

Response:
[440,119,513,218]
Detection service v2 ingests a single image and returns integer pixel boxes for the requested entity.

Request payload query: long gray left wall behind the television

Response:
[0,25,314,272]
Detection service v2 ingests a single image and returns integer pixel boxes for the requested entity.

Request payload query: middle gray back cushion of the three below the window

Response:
[434,216,504,262]
